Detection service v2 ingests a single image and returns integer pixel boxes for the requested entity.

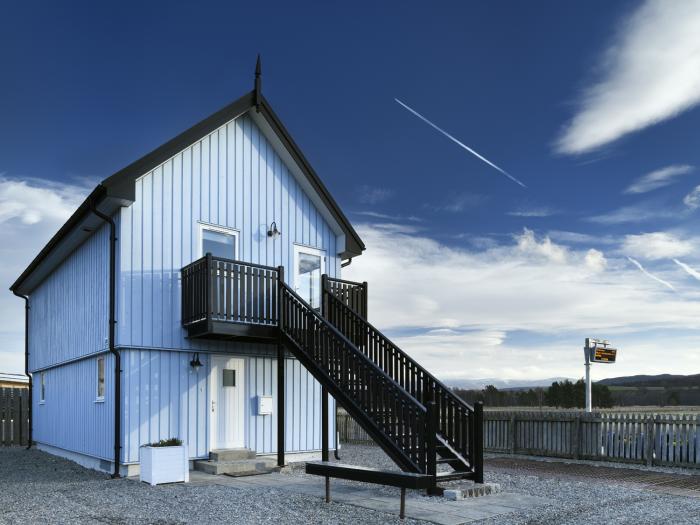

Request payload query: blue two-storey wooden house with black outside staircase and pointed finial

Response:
[11,62,480,492]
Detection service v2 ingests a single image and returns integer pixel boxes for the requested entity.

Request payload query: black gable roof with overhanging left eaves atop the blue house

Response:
[10,84,365,293]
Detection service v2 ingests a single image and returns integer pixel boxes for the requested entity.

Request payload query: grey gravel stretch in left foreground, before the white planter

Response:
[0,448,422,525]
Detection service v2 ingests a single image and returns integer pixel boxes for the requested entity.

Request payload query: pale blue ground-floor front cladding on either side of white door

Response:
[122,350,335,463]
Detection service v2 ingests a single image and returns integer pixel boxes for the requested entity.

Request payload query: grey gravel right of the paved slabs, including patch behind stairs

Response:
[320,445,700,525]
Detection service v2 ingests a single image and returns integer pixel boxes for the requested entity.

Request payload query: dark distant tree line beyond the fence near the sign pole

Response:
[455,379,613,408]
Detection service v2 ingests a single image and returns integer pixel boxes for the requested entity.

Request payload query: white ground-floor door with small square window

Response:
[210,355,245,450]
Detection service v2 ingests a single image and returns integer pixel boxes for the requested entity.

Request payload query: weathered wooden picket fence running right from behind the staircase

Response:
[338,411,700,468]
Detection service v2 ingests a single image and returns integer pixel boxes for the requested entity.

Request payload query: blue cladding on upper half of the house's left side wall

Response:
[29,221,109,370]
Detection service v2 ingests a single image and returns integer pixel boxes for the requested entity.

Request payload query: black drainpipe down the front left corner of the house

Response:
[90,202,122,478]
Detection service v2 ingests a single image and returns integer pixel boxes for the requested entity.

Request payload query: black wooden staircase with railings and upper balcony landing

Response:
[182,255,483,489]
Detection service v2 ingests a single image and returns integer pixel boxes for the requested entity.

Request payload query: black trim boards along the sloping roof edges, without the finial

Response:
[10,86,365,291]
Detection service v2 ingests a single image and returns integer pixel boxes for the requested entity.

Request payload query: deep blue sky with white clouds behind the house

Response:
[0,1,700,380]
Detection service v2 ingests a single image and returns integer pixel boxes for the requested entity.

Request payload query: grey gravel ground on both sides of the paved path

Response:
[0,445,700,525]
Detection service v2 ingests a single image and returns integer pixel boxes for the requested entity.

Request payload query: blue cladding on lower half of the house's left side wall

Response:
[32,354,114,461]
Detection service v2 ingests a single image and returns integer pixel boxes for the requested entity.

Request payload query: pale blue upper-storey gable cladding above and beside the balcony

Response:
[117,111,340,351]
